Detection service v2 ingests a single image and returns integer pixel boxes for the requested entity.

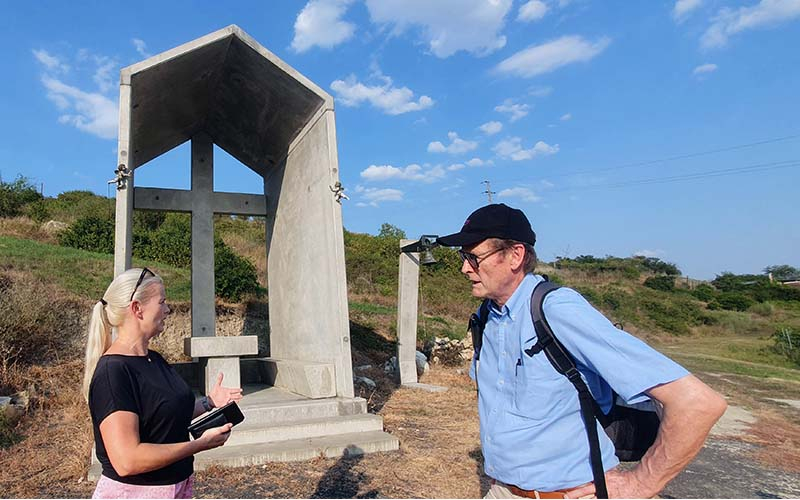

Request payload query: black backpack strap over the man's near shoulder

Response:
[525,281,608,498]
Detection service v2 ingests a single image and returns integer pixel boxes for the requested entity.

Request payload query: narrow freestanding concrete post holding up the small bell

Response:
[397,240,419,385]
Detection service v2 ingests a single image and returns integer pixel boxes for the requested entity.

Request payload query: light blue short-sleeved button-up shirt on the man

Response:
[470,274,689,491]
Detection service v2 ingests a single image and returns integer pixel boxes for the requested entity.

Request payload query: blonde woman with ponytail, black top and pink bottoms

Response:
[83,268,242,498]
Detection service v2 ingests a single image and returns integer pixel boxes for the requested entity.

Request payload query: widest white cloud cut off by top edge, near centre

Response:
[366,0,512,58]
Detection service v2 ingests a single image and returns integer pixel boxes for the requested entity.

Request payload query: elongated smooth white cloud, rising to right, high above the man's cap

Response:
[495,35,611,78]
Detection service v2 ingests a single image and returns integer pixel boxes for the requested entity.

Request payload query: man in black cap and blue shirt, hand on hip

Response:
[437,204,727,498]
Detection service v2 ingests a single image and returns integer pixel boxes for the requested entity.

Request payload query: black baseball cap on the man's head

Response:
[436,203,536,247]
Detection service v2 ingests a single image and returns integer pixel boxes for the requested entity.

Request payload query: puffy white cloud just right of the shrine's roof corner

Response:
[331,75,434,115]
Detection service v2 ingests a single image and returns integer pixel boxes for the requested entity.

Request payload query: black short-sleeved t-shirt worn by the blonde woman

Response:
[89,351,194,485]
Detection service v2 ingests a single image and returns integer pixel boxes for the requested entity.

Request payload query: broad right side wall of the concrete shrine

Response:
[264,109,354,397]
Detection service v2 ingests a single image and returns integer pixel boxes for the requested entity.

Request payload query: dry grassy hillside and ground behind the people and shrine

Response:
[0,185,800,497]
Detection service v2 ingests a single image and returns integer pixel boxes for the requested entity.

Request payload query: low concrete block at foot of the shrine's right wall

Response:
[258,358,336,399]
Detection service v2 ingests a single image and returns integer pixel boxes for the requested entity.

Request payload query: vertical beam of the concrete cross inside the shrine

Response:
[192,134,216,337]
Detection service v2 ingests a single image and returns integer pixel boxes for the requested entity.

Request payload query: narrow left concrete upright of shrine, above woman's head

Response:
[114,83,133,277]
